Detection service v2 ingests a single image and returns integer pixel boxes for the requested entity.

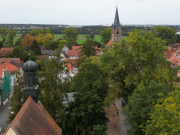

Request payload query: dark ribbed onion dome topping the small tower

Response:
[22,60,38,72]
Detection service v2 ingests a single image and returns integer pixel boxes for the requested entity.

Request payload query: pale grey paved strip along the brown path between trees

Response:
[116,98,131,135]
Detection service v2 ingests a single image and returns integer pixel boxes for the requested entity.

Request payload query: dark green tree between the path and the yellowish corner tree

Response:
[126,81,172,135]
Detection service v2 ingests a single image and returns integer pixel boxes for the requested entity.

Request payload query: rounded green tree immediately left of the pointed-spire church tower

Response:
[100,28,111,44]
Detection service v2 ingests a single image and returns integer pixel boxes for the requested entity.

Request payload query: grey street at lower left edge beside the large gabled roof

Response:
[0,102,10,131]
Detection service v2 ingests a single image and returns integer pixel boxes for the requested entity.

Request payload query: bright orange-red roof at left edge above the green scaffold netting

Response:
[0,62,18,78]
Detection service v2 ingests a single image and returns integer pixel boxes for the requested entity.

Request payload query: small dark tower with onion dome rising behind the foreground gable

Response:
[22,60,38,103]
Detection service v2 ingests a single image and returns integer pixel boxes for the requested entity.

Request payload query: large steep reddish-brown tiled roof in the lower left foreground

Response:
[5,97,62,135]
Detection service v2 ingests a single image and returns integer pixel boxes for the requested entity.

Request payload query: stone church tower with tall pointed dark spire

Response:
[111,8,122,43]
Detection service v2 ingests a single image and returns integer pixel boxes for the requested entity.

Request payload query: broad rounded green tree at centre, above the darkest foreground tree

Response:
[72,61,109,100]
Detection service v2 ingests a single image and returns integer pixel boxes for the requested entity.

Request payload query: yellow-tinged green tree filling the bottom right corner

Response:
[146,89,180,135]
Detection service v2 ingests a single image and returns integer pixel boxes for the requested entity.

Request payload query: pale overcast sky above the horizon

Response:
[0,0,180,25]
